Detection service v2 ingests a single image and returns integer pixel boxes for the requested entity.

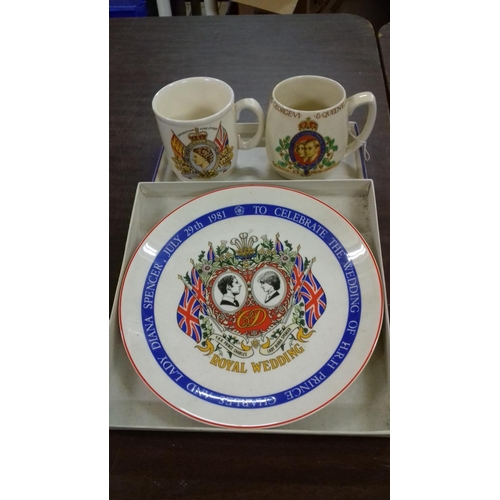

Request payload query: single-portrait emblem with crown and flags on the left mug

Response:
[170,123,234,179]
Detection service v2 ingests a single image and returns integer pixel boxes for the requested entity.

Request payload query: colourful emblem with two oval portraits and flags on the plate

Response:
[177,232,327,359]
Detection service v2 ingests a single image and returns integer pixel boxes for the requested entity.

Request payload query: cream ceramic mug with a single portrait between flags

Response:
[152,77,265,181]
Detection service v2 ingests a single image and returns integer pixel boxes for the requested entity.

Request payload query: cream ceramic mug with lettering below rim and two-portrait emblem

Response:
[266,75,377,179]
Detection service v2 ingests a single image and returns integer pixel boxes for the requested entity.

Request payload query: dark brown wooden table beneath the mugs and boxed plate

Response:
[109,14,390,500]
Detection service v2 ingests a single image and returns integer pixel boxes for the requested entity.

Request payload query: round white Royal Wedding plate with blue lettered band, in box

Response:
[118,185,383,428]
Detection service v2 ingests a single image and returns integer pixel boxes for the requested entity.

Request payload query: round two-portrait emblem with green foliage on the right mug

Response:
[273,118,339,176]
